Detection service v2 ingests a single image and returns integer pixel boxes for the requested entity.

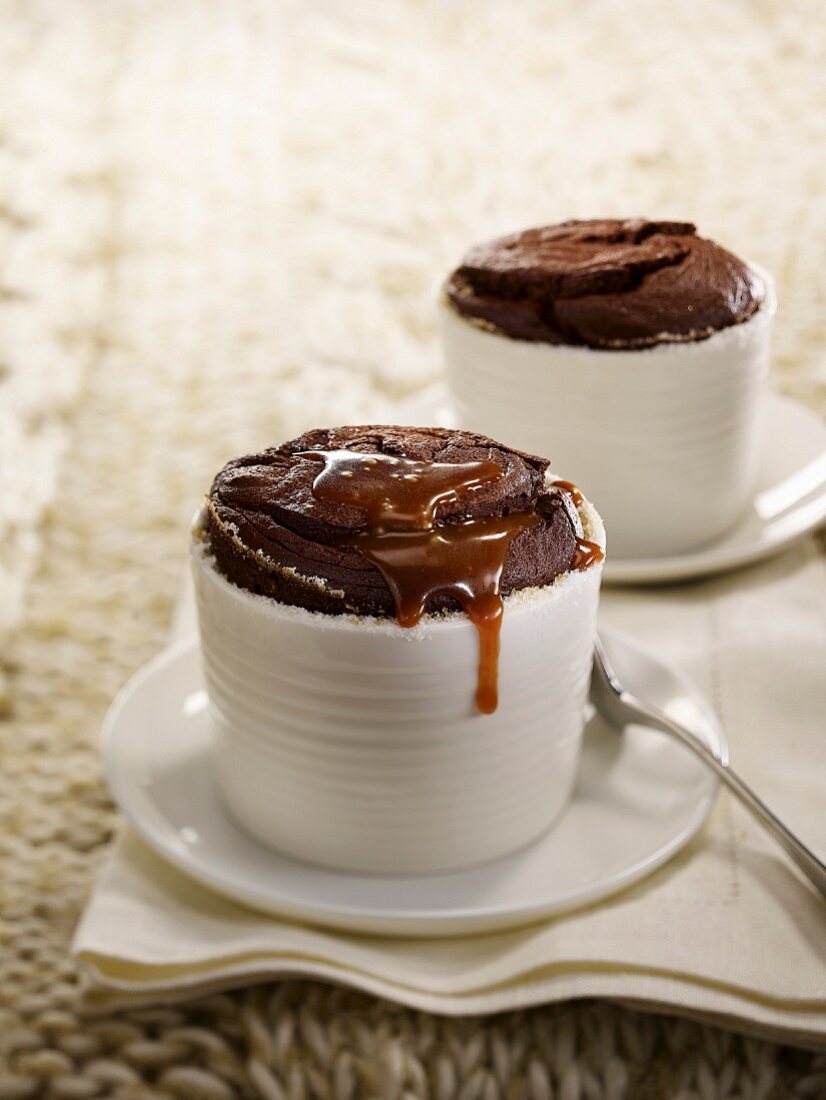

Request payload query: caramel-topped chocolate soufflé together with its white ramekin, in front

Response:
[190,426,605,875]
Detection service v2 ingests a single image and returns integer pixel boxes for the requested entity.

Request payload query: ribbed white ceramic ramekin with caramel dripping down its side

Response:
[191,505,605,873]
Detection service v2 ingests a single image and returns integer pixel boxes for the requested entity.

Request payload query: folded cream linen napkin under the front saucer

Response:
[75,539,826,1045]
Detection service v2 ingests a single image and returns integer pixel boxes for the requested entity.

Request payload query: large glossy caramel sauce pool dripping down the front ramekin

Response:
[302,451,538,714]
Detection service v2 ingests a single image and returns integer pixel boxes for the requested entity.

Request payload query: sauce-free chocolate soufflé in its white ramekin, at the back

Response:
[438,219,775,563]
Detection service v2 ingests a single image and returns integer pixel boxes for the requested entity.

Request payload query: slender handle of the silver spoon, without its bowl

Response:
[619,690,826,898]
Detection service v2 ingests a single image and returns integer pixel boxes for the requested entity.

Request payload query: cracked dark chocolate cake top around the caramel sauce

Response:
[205,426,582,616]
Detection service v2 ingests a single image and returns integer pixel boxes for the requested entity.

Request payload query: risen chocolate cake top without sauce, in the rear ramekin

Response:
[447,218,766,349]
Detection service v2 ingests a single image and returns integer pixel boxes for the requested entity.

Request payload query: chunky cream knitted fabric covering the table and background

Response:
[0,0,826,1100]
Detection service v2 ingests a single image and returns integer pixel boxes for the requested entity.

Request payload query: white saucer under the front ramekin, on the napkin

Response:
[103,634,727,936]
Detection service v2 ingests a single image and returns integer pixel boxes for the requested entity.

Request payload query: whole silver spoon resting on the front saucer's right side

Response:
[591,638,826,898]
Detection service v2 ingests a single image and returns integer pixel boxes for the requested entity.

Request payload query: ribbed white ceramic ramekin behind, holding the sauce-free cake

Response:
[439,265,775,559]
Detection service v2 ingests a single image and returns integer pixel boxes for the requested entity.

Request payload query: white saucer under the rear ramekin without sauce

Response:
[399,385,826,584]
